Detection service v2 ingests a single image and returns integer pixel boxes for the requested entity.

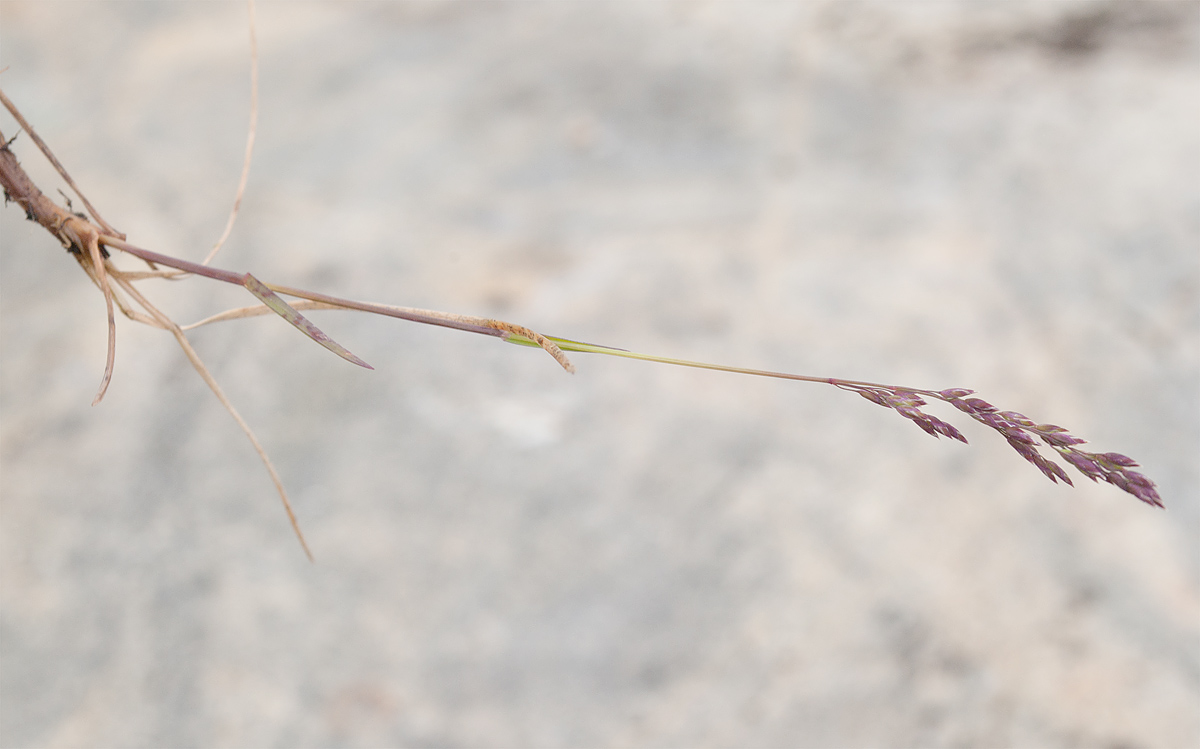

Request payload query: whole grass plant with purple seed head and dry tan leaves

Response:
[0,4,1163,559]
